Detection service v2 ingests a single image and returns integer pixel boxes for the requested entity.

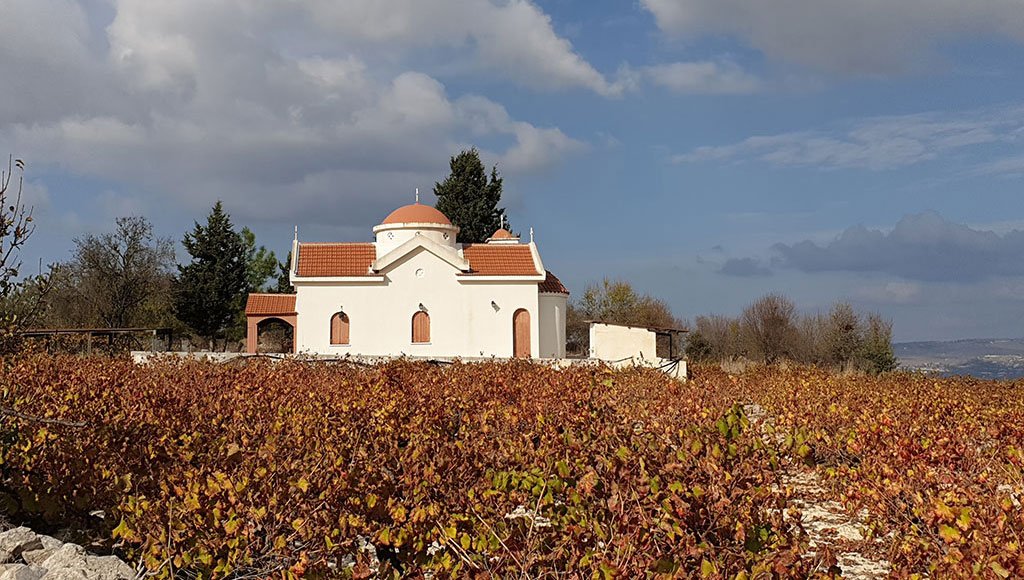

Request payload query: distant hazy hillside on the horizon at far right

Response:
[893,338,1024,379]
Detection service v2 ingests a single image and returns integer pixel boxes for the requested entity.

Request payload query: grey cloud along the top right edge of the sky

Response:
[641,0,1024,75]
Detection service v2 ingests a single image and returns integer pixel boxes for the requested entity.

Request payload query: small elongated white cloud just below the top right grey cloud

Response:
[644,61,762,94]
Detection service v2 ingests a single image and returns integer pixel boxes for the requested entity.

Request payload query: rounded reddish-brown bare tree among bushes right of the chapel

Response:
[740,294,797,365]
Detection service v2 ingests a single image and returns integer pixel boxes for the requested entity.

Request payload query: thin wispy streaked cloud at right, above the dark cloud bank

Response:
[673,107,1024,171]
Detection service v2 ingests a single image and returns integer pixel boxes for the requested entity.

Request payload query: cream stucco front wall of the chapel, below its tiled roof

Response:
[295,248,540,358]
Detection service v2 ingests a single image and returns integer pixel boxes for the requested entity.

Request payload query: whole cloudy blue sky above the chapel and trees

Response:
[6,0,1024,340]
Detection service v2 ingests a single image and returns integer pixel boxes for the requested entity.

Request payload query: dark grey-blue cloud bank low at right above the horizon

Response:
[773,212,1024,282]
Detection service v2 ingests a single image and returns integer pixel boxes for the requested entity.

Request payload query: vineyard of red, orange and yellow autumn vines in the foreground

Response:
[0,355,1024,578]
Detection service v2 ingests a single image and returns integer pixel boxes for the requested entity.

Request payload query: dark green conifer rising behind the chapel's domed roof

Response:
[434,148,505,243]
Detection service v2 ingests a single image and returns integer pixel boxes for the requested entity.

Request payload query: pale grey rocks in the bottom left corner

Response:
[0,528,136,580]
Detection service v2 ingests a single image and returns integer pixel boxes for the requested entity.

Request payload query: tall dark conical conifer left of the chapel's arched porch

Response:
[174,201,249,348]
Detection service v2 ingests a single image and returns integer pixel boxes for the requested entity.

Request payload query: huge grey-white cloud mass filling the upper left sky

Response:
[0,0,589,225]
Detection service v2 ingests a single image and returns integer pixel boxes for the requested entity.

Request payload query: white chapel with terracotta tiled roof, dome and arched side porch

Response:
[246,202,568,359]
